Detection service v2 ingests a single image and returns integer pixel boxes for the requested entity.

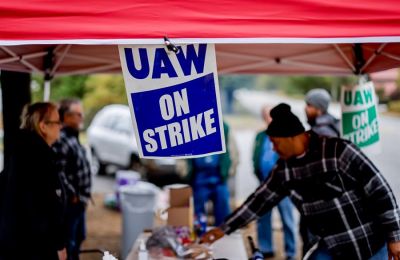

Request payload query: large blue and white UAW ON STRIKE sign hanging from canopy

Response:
[119,44,225,158]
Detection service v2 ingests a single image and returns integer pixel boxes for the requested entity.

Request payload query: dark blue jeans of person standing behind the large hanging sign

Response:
[193,183,230,226]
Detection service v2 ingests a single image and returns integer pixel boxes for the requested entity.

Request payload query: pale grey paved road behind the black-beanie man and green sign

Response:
[235,90,400,201]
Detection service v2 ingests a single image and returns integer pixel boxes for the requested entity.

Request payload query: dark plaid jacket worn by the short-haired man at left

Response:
[53,127,91,204]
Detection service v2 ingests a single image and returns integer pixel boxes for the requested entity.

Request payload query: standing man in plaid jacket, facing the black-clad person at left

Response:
[53,99,91,260]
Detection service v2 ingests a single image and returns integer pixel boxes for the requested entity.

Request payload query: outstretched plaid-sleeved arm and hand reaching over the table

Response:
[200,167,288,243]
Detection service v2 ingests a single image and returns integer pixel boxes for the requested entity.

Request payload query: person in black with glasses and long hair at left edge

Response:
[0,102,66,260]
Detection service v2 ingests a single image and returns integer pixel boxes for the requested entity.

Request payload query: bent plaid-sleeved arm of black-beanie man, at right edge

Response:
[339,143,400,256]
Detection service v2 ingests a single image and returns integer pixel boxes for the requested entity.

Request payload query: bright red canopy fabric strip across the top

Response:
[0,0,400,43]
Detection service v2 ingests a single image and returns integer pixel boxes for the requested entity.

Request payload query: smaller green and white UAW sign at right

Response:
[341,81,380,154]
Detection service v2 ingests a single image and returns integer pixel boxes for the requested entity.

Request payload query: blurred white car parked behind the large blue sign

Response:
[87,105,182,186]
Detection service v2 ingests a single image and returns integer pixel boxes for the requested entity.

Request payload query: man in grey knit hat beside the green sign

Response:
[305,88,340,137]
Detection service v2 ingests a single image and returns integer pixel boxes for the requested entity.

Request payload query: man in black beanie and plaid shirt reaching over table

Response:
[201,104,400,260]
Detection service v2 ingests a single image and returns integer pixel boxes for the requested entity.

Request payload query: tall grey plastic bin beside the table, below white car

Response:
[119,181,160,259]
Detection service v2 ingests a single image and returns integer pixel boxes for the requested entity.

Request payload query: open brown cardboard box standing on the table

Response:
[167,185,194,228]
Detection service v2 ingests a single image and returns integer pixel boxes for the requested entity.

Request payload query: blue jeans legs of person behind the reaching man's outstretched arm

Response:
[257,197,296,257]
